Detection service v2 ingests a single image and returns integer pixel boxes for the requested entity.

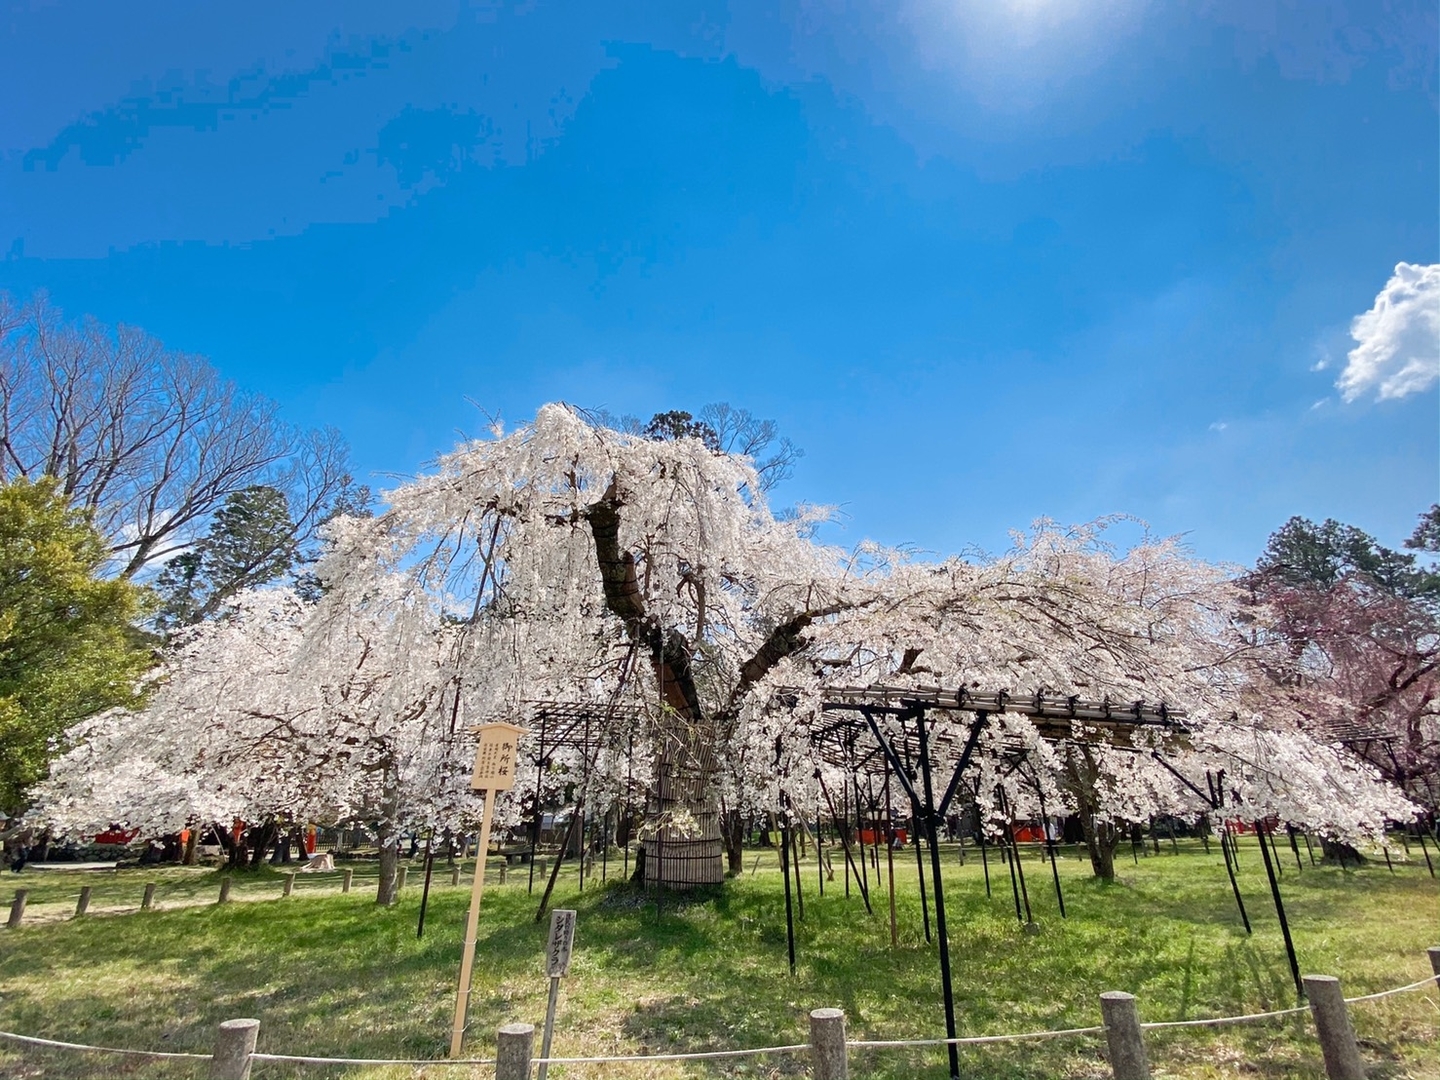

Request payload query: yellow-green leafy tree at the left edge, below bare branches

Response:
[0,478,151,812]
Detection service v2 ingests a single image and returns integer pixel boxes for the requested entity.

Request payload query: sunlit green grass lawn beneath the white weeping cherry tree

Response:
[0,838,1440,1080]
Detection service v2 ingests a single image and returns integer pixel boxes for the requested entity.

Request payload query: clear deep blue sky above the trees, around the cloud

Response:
[0,0,1440,562]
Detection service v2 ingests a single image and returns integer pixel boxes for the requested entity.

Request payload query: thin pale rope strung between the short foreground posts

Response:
[0,975,1440,1068]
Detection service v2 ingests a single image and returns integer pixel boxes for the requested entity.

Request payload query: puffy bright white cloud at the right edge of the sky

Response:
[1335,262,1440,402]
